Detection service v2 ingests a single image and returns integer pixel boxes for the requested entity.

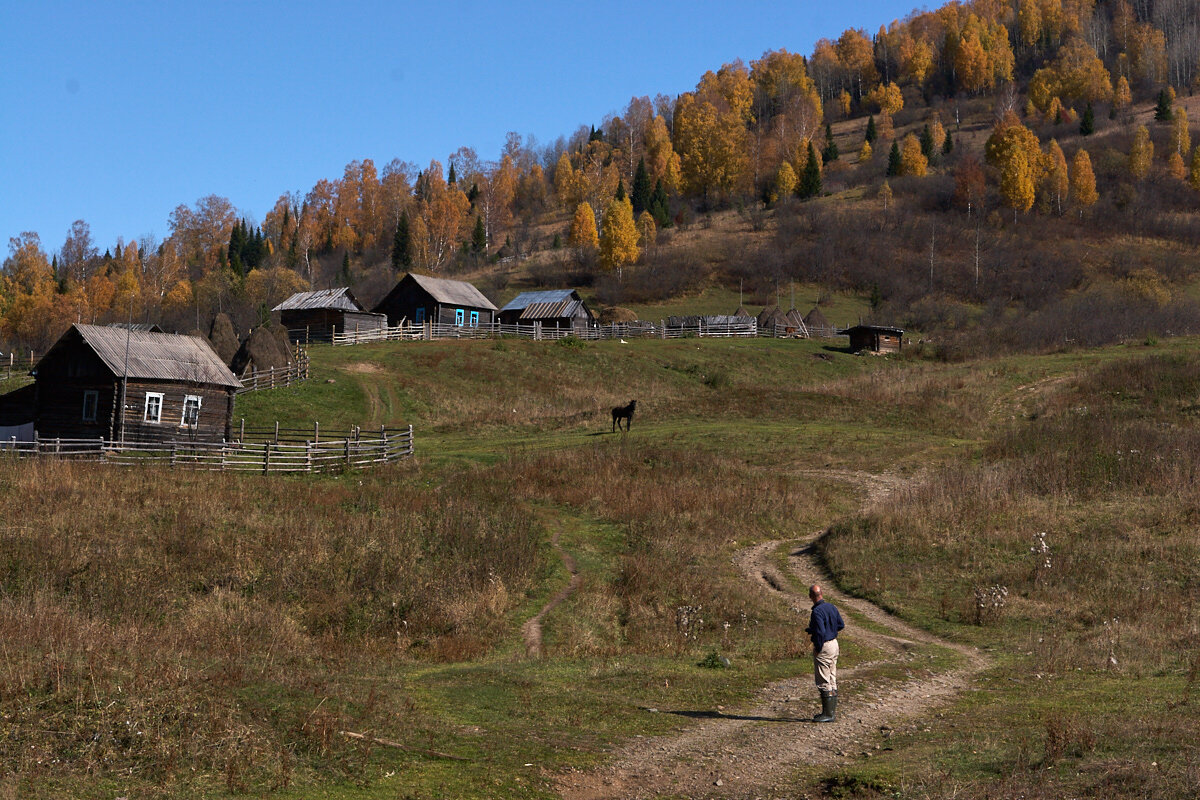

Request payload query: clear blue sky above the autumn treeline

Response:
[0,0,913,255]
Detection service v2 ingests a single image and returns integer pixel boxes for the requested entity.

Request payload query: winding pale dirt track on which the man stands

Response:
[556,474,988,800]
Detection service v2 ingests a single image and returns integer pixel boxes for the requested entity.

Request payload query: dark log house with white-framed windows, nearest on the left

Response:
[34,325,241,441]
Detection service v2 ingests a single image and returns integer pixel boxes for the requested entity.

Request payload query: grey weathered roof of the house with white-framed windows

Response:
[38,324,241,389]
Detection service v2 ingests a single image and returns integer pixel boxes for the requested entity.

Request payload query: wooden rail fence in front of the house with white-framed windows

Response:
[0,426,413,475]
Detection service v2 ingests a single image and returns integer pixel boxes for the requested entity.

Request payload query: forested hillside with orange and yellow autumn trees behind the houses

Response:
[0,0,1200,355]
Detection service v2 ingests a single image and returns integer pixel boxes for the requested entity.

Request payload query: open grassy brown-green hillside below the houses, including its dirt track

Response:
[0,338,1200,798]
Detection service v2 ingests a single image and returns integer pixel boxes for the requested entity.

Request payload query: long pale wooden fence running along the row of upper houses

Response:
[321,319,839,345]
